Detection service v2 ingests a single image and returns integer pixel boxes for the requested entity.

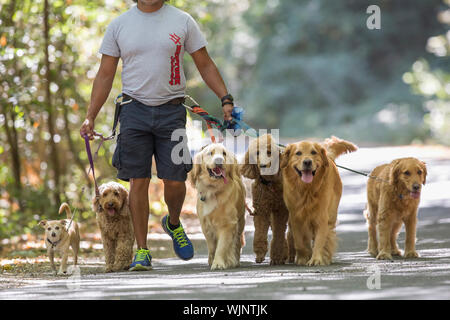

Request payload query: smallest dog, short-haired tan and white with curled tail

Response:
[39,202,80,275]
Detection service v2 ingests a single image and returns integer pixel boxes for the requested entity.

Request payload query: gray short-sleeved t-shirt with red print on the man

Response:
[99,4,207,106]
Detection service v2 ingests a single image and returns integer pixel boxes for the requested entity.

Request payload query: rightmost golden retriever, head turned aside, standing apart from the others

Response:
[365,158,427,260]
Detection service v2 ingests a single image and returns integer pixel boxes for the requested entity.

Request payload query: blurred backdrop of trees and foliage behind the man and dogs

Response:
[0,0,450,238]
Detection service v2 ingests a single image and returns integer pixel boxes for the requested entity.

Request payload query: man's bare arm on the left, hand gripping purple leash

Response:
[80,54,119,139]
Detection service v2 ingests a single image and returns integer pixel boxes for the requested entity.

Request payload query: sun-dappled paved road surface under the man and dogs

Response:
[0,147,450,299]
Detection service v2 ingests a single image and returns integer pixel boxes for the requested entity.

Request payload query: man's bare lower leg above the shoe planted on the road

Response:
[129,178,150,249]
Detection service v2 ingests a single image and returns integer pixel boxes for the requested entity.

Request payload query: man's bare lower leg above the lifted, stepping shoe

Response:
[163,179,186,229]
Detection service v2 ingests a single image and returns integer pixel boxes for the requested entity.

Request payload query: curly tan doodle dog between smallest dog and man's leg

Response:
[93,182,134,272]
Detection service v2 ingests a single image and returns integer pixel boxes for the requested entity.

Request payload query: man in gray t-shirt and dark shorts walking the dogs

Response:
[80,0,233,271]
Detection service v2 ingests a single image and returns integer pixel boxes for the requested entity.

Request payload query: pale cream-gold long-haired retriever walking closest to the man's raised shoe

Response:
[189,144,245,270]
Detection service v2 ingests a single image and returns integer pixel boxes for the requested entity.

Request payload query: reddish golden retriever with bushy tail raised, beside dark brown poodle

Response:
[281,137,357,266]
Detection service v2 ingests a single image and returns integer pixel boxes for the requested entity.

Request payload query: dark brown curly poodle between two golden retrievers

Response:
[241,135,295,265]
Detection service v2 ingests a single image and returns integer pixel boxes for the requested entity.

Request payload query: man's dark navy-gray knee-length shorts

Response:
[112,100,192,181]
